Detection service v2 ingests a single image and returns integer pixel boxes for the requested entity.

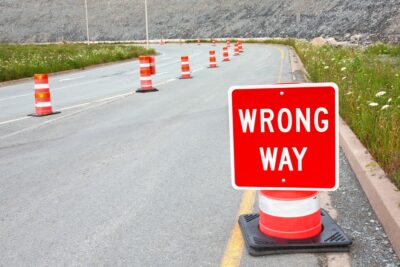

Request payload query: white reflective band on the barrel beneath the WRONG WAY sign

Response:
[258,193,320,218]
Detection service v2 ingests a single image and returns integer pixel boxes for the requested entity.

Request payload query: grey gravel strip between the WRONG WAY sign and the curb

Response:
[330,152,400,267]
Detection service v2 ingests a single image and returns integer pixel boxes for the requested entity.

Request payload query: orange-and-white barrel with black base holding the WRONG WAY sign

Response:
[239,188,352,256]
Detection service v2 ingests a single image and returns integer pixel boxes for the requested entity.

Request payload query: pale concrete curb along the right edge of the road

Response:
[289,47,400,257]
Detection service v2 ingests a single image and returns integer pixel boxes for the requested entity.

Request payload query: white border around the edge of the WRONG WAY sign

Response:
[228,83,339,191]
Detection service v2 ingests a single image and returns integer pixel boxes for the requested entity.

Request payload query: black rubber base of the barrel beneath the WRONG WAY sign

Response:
[239,209,352,256]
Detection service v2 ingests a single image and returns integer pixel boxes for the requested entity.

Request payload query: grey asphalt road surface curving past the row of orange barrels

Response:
[0,44,396,266]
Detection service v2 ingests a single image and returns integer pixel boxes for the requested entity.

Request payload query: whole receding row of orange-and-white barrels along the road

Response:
[29,40,243,117]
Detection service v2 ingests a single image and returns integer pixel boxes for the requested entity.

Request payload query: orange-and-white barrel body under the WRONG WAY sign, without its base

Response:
[259,191,322,239]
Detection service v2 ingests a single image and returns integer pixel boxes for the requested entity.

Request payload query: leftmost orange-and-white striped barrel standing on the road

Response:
[33,74,53,116]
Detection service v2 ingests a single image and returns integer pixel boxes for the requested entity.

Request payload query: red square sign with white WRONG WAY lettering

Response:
[229,83,339,191]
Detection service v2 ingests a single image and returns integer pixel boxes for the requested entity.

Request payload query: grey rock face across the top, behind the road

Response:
[0,0,400,42]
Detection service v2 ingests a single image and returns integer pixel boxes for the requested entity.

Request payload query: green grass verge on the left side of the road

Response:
[0,44,155,81]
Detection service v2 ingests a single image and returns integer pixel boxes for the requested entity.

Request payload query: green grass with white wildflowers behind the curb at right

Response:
[244,39,400,188]
